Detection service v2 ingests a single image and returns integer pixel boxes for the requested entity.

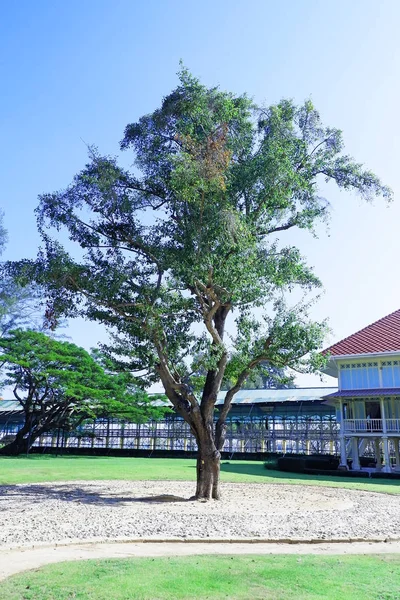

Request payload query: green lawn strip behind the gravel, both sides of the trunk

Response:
[0,454,400,494]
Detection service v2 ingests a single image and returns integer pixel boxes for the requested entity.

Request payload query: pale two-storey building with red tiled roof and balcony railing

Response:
[324,310,400,473]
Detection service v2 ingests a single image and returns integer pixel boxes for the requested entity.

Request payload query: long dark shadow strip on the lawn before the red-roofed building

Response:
[221,461,400,488]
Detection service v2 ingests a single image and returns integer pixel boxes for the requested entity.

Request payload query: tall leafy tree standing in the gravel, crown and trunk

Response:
[14,69,391,499]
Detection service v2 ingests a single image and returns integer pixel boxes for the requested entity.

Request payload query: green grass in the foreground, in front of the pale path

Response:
[0,555,400,600]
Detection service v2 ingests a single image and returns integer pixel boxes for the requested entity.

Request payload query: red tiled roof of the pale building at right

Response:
[323,310,400,356]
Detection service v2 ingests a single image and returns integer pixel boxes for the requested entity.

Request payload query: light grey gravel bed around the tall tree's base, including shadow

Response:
[0,481,400,549]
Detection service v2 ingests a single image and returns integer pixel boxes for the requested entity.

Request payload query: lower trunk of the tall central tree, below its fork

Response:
[195,441,221,500]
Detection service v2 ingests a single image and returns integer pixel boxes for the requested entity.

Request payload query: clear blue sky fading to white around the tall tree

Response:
[0,0,400,384]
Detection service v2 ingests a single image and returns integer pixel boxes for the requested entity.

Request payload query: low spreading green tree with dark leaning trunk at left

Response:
[0,330,163,455]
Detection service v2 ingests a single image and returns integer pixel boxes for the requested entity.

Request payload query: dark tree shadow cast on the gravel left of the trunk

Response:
[0,482,193,511]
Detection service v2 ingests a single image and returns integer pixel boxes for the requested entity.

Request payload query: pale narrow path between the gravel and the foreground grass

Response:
[0,541,400,580]
